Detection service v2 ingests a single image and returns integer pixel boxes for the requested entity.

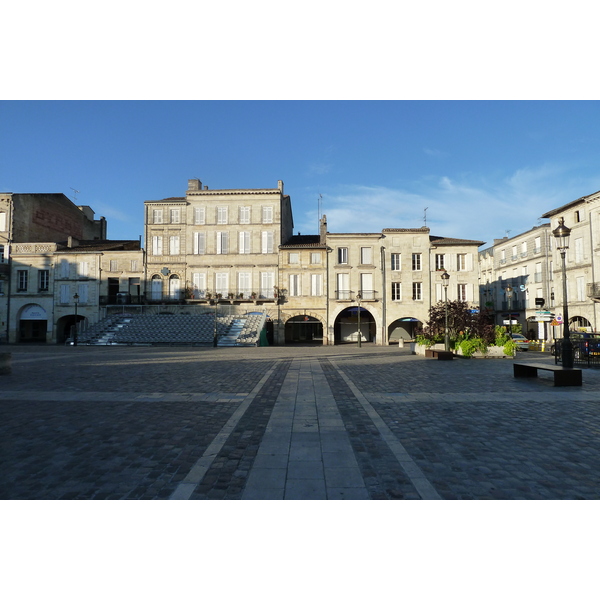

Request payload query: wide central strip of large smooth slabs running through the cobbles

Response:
[242,359,369,500]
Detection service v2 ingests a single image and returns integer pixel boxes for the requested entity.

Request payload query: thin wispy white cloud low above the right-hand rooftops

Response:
[295,165,600,245]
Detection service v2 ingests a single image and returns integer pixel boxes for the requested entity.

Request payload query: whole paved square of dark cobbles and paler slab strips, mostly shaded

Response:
[0,344,600,499]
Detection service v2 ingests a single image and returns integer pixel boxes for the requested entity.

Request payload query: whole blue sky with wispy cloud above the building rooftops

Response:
[0,100,600,243]
